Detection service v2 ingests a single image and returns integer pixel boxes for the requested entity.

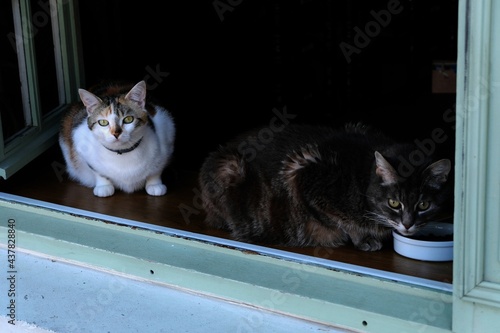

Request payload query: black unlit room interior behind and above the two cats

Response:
[79,0,458,170]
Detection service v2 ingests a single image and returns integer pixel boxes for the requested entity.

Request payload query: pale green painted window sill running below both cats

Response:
[0,193,452,332]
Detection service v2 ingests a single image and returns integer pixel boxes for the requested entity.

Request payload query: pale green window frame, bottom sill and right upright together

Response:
[0,0,500,333]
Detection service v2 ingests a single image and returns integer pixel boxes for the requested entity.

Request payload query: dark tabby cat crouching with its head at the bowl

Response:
[199,124,451,251]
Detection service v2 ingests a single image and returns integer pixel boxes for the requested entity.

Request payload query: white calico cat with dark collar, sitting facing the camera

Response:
[59,81,175,197]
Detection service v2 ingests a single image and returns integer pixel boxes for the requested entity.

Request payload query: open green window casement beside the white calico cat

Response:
[0,0,83,179]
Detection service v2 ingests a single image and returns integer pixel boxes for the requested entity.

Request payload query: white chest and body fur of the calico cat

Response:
[68,108,175,192]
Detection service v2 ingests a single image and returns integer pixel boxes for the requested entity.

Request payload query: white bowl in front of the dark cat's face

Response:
[392,222,453,261]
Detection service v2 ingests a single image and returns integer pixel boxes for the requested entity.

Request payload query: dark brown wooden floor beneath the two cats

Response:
[0,146,452,283]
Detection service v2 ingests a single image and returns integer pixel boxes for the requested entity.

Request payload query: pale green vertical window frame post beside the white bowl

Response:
[453,0,500,332]
